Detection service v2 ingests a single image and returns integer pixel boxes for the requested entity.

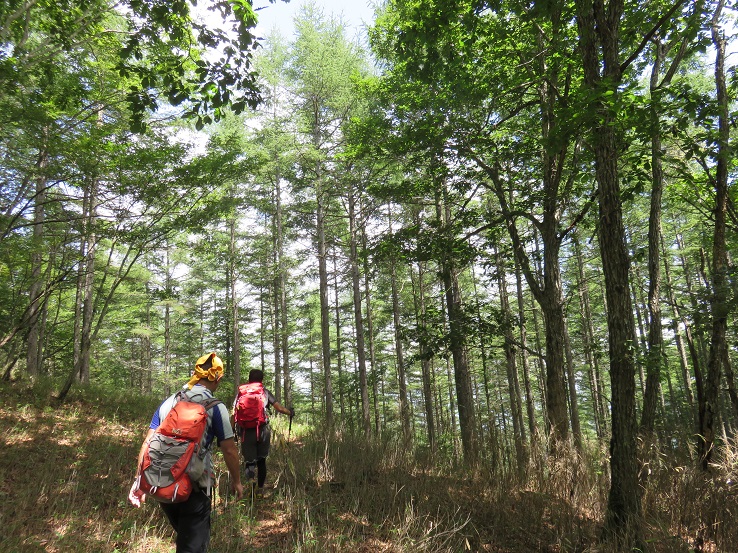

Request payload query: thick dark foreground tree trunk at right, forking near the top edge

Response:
[576,0,642,536]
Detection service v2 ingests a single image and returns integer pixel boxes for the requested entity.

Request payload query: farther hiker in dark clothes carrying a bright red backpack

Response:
[231,369,295,495]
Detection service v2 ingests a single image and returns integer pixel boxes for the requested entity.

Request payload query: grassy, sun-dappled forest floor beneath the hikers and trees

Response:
[0,384,738,553]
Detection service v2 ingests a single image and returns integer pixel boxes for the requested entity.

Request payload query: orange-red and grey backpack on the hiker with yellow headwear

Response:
[138,392,220,503]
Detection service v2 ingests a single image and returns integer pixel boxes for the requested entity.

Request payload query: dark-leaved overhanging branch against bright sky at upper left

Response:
[118,0,259,130]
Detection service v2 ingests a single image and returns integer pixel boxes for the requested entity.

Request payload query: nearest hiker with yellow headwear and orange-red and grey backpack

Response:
[128,353,243,553]
